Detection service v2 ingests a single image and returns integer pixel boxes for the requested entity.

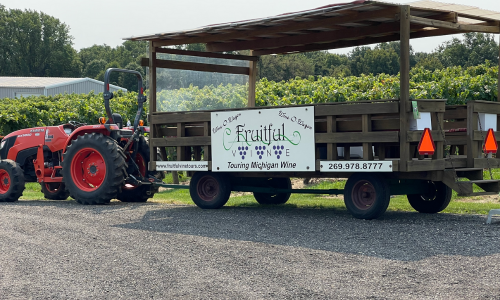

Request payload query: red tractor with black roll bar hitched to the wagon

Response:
[0,68,161,204]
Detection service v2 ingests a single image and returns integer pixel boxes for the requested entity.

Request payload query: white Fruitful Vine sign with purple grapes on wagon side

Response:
[211,106,315,172]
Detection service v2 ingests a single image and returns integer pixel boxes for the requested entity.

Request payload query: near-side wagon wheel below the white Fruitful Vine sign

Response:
[189,172,231,209]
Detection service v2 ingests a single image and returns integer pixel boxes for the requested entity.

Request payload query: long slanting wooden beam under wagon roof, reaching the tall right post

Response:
[207,23,399,52]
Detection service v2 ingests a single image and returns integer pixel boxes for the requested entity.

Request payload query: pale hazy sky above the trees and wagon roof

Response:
[0,0,500,54]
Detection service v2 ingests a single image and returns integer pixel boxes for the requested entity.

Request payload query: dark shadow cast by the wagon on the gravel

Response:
[109,206,500,261]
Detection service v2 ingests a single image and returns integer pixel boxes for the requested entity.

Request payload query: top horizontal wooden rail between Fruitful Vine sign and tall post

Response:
[314,102,399,116]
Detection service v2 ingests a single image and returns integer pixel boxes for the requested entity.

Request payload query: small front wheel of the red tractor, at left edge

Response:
[0,159,24,202]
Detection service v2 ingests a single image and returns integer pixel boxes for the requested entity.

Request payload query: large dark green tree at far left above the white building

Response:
[0,5,81,77]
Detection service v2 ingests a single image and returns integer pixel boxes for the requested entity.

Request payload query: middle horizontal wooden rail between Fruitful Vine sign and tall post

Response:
[315,131,399,143]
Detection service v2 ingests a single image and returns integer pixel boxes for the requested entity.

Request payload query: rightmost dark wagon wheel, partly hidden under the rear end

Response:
[406,181,452,214]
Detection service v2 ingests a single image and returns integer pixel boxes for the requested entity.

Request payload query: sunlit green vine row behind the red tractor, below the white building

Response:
[0,91,148,135]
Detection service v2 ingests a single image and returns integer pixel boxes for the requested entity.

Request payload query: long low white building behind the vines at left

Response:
[0,77,127,99]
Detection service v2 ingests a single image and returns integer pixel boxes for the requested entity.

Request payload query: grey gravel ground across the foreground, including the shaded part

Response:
[0,201,500,299]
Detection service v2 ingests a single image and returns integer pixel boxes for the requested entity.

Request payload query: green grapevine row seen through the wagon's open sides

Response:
[157,63,498,111]
